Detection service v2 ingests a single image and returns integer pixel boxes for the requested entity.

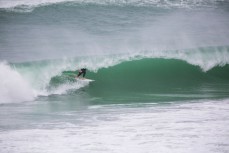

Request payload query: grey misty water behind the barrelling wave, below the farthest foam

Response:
[0,1,229,62]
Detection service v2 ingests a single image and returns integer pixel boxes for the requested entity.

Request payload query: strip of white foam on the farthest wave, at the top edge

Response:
[0,0,224,9]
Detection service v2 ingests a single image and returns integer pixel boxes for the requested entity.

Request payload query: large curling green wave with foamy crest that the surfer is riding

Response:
[0,47,229,103]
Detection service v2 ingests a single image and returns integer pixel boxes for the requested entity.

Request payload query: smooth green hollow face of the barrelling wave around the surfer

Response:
[41,58,229,103]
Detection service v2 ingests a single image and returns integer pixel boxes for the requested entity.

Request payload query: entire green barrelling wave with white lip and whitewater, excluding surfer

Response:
[1,48,229,103]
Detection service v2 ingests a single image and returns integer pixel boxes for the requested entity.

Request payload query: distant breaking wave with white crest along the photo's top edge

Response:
[0,0,227,12]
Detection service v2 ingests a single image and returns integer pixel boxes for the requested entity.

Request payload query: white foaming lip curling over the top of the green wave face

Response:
[63,47,229,72]
